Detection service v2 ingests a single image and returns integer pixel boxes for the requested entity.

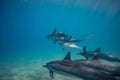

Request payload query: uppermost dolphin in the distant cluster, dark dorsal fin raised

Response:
[46,28,68,40]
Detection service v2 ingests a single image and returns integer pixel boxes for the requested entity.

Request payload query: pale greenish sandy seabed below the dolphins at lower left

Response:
[0,60,82,80]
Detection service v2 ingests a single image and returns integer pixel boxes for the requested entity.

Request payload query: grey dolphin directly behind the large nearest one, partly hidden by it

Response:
[74,53,120,76]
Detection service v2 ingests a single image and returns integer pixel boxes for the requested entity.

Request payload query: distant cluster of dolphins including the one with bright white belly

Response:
[46,28,82,50]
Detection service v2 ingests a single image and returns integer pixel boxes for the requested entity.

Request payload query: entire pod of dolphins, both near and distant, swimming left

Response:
[43,28,120,80]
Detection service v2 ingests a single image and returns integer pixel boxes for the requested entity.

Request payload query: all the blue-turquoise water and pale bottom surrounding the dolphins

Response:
[0,0,120,80]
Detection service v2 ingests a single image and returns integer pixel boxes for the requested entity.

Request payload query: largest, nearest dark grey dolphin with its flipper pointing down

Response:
[43,52,117,80]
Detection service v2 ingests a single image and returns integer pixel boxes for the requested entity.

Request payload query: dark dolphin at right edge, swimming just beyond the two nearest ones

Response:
[78,46,120,62]
